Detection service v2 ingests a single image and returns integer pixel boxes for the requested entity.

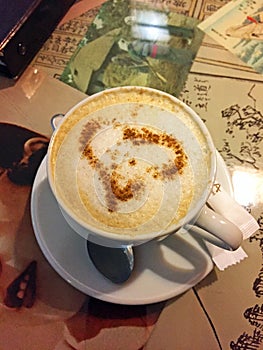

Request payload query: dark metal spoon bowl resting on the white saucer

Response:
[87,241,134,283]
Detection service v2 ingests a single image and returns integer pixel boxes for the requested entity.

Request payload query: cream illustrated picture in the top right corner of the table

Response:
[198,0,263,73]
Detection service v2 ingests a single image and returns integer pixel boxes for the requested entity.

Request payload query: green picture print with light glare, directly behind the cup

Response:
[61,0,206,96]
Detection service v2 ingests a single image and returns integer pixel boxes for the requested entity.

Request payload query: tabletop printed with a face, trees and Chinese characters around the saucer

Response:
[0,0,263,350]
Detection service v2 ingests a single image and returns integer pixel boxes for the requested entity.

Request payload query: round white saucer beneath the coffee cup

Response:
[31,155,232,305]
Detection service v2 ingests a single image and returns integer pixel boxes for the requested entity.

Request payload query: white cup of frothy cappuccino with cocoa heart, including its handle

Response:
[47,86,242,250]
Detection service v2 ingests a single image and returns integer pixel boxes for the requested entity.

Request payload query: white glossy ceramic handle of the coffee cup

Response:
[189,205,243,251]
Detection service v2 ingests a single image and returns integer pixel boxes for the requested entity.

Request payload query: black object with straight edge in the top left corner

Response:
[0,0,75,78]
